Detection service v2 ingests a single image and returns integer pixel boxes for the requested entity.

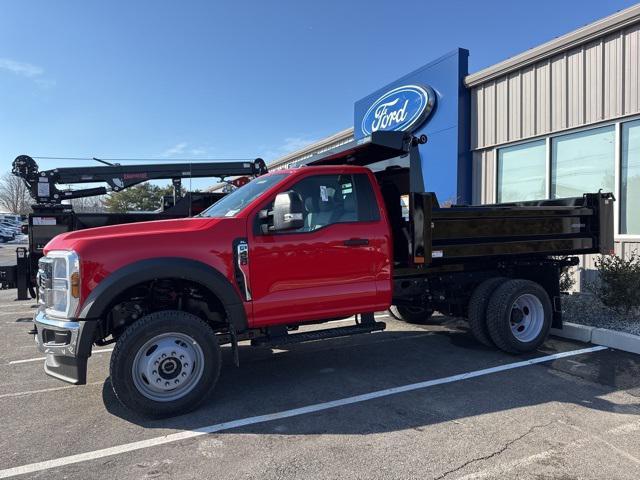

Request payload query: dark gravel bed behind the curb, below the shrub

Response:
[562,293,640,335]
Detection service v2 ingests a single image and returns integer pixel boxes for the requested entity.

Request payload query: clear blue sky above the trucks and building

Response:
[0,0,635,190]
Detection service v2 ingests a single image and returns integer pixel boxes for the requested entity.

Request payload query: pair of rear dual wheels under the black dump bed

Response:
[469,277,553,353]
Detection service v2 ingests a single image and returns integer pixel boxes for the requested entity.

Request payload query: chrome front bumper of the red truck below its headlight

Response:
[33,308,95,385]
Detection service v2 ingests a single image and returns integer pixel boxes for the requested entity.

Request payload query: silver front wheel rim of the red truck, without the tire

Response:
[131,332,204,402]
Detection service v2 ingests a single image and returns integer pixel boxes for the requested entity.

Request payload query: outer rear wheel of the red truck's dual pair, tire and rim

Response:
[487,280,553,353]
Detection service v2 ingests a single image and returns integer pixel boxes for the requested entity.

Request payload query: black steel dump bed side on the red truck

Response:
[411,193,613,265]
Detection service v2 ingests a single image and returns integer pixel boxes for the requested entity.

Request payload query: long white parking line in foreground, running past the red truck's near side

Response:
[0,346,607,478]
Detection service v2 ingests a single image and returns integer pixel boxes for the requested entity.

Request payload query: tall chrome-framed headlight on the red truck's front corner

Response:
[38,250,80,318]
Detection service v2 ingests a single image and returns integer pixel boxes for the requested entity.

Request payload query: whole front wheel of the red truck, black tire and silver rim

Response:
[109,310,221,418]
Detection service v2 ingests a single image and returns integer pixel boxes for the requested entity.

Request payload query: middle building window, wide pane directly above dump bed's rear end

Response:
[551,125,615,198]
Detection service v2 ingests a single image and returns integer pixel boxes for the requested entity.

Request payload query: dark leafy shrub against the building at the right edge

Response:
[588,252,640,315]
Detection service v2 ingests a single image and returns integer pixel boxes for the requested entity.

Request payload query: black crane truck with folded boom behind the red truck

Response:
[0,155,267,300]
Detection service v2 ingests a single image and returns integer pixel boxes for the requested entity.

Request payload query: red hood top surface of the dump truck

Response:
[44,218,225,254]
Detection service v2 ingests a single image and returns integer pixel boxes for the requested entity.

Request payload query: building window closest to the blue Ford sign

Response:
[497,140,547,202]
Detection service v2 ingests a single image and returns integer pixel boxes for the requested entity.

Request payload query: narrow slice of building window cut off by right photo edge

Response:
[620,120,640,234]
